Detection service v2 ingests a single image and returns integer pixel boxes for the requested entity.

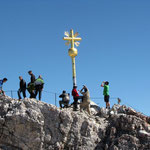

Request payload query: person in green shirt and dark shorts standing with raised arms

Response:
[101,81,110,109]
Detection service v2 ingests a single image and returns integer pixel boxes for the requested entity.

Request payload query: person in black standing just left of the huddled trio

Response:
[18,76,26,99]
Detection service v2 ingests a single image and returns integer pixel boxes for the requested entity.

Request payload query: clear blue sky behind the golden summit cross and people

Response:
[0,0,150,115]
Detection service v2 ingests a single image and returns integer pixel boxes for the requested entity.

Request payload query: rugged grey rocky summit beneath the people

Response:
[0,96,150,150]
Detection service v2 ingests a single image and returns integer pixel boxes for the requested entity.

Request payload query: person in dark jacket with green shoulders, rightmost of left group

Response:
[34,75,44,100]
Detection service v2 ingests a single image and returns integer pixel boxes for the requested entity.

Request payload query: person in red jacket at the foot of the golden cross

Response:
[72,86,82,111]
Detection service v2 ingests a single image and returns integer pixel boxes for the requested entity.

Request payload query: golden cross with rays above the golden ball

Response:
[63,29,82,48]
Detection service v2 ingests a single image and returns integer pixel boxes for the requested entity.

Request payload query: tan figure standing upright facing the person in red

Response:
[80,85,91,115]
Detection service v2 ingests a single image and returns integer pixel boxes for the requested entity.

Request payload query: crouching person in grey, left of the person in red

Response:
[59,91,70,108]
